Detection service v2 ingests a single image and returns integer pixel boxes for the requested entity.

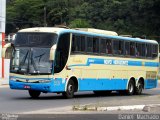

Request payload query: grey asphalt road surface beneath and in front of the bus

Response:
[0,83,160,114]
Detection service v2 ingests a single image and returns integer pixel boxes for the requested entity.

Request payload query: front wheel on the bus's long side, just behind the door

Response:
[62,80,75,99]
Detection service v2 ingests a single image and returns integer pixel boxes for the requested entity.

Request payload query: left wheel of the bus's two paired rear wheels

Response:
[126,80,135,95]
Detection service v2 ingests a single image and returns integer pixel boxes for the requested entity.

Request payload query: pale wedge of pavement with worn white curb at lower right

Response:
[23,95,160,114]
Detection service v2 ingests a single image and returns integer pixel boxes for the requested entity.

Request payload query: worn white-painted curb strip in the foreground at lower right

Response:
[73,104,160,112]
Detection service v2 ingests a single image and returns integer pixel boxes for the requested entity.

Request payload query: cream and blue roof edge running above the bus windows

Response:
[18,27,158,44]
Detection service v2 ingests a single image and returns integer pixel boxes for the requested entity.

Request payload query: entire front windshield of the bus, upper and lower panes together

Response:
[10,33,57,74]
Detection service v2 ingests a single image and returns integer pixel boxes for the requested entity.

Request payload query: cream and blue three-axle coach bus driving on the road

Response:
[2,27,159,98]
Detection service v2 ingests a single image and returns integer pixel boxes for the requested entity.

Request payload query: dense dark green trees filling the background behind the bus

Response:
[7,0,160,39]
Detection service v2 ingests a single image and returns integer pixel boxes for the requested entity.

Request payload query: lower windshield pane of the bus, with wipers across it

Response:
[10,47,52,75]
